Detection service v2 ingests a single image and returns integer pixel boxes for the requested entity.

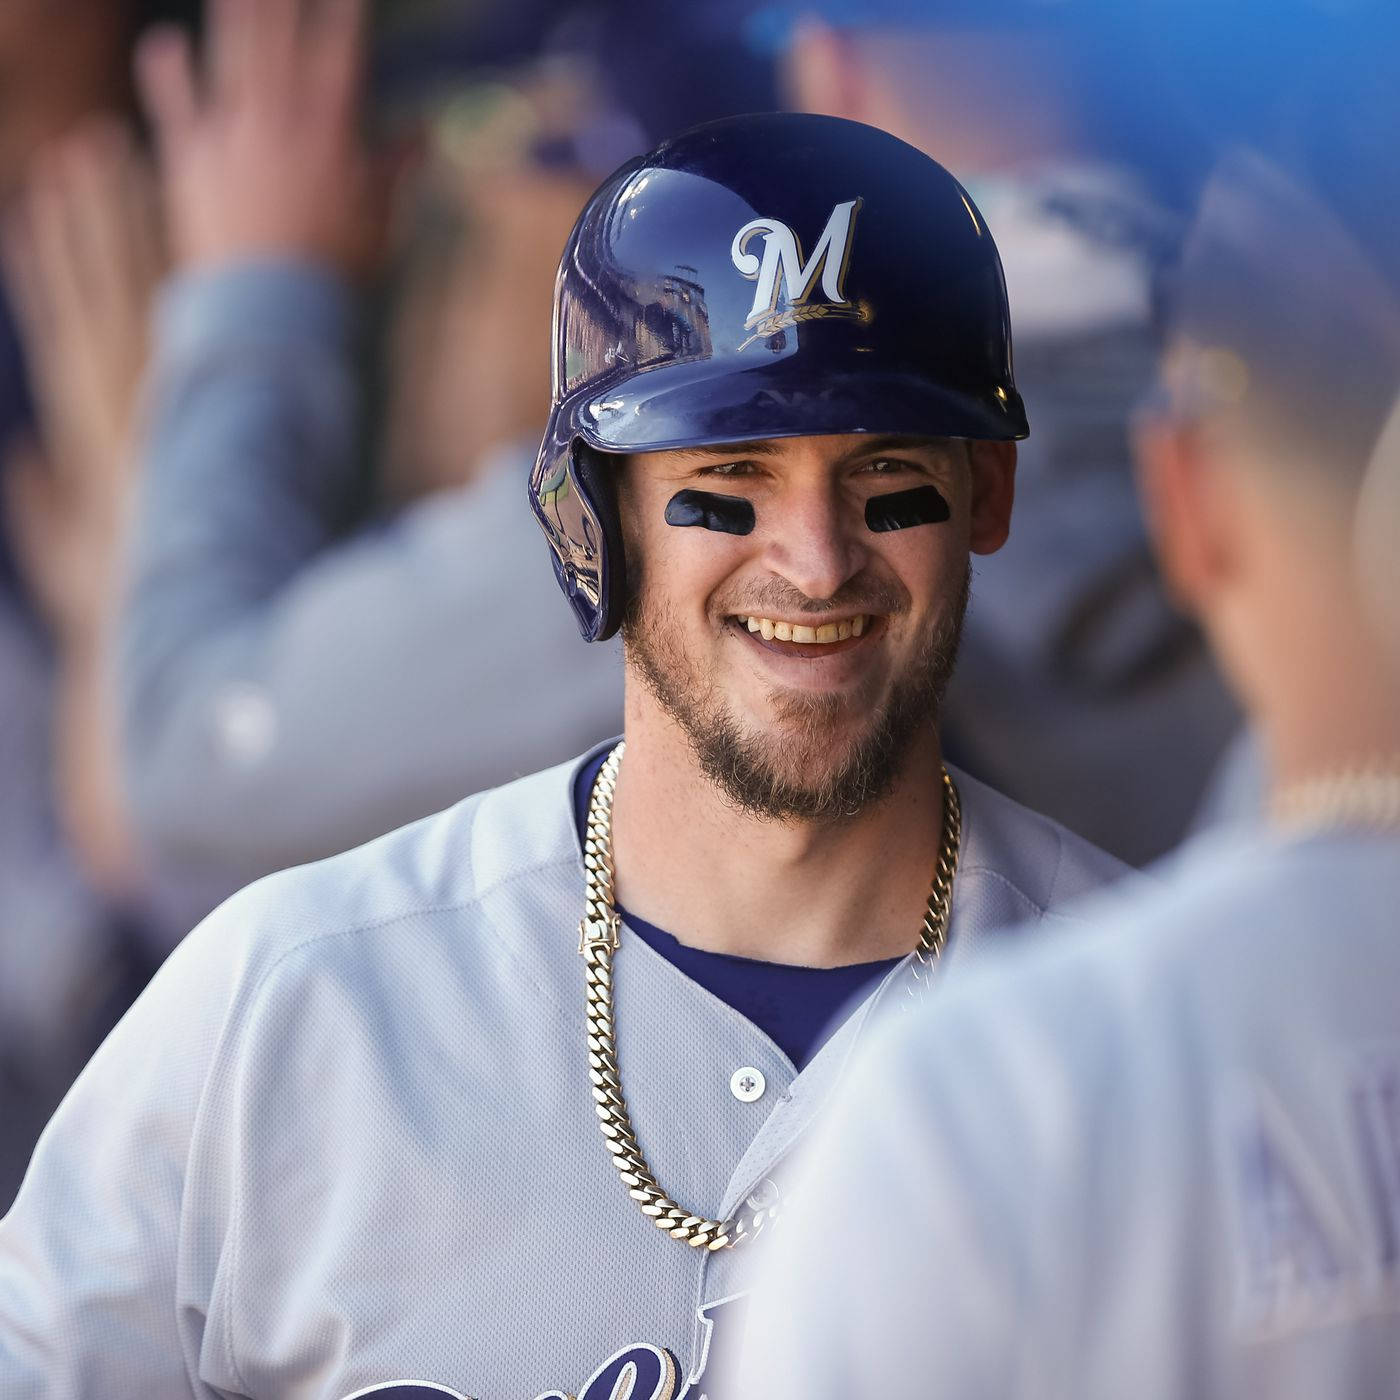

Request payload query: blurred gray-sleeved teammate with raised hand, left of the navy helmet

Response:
[113,0,622,889]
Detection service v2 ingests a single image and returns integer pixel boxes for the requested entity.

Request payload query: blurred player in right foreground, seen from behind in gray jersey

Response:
[738,133,1400,1400]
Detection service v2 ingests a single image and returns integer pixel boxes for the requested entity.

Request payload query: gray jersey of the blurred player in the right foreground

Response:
[738,833,1400,1400]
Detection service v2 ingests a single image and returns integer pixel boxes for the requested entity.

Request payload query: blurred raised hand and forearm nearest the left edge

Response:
[0,120,164,893]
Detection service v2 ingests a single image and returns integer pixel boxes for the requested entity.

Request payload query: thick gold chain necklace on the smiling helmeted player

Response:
[578,743,962,1250]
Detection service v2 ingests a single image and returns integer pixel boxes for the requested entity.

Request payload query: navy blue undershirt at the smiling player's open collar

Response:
[574,749,900,1070]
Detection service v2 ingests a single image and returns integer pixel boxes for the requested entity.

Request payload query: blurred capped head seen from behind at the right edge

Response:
[1138,32,1400,783]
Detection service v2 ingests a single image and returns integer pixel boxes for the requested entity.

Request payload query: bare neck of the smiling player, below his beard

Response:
[613,678,942,967]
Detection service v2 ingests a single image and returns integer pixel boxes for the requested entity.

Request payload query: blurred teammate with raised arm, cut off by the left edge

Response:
[0,0,197,1208]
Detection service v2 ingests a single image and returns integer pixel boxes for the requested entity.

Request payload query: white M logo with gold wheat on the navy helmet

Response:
[729,199,869,344]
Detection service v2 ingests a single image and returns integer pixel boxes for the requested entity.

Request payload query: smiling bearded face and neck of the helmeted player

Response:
[596,431,1014,991]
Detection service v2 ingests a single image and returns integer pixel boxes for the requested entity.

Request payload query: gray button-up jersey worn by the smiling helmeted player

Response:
[0,763,1121,1400]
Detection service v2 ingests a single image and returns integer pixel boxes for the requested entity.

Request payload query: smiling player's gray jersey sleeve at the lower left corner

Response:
[0,901,239,1400]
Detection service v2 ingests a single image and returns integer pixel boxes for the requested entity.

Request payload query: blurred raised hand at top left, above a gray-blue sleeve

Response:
[137,0,389,273]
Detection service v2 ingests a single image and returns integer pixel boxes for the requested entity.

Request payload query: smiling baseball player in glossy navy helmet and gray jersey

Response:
[0,115,1121,1400]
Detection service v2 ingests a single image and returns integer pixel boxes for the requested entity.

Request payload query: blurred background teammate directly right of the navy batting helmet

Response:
[785,0,1239,864]
